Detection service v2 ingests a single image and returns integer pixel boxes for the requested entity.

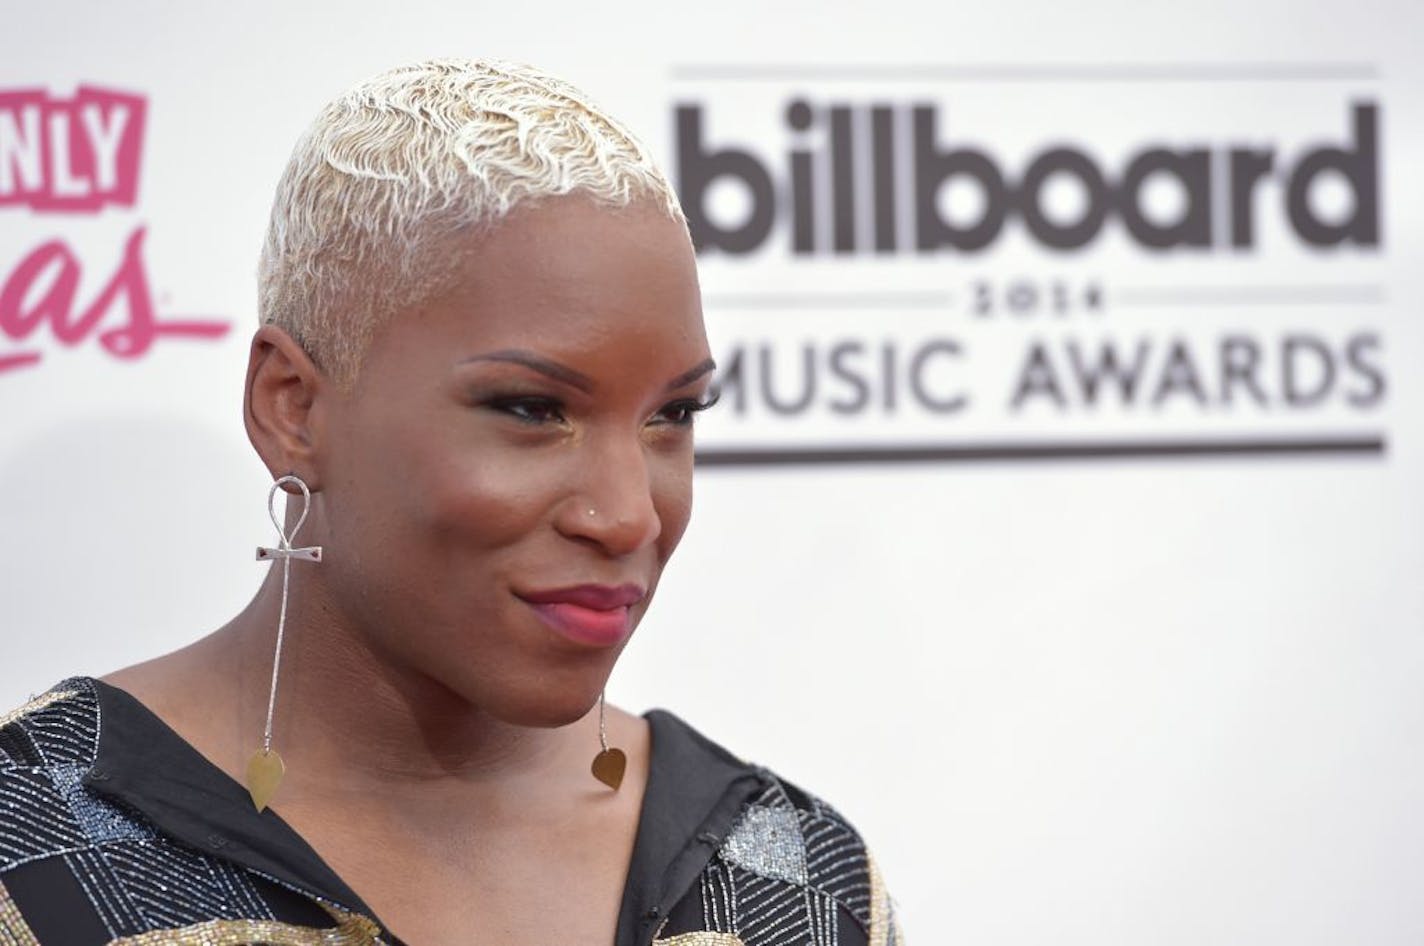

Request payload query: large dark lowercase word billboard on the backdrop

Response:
[676,98,1380,255]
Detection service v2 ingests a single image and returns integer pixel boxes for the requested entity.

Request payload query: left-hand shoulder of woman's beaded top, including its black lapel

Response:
[0,677,380,946]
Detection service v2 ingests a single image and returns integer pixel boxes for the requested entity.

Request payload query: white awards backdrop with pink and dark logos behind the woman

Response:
[0,0,1424,946]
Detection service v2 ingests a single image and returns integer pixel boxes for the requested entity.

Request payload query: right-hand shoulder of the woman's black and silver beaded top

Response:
[646,710,903,945]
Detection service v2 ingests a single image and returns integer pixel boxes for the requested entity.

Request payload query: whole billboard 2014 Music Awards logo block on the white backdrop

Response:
[669,75,1390,466]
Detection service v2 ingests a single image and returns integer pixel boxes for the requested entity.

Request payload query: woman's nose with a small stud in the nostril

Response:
[560,440,662,557]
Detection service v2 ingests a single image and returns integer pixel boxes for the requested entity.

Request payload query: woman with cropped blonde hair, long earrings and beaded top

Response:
[0,61,897,946]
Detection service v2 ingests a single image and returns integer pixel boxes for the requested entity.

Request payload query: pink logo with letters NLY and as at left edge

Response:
[0,87,231,372]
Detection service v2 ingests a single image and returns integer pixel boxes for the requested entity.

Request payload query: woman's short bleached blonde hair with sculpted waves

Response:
[258,58,686,390]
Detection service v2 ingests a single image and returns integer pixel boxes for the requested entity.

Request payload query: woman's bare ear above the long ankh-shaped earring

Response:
[242,325,329,492]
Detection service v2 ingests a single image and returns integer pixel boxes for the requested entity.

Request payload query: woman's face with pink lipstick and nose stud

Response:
[319,198,712,725]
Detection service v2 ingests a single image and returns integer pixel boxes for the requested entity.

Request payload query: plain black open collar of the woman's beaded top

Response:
[83,678,765,946]
